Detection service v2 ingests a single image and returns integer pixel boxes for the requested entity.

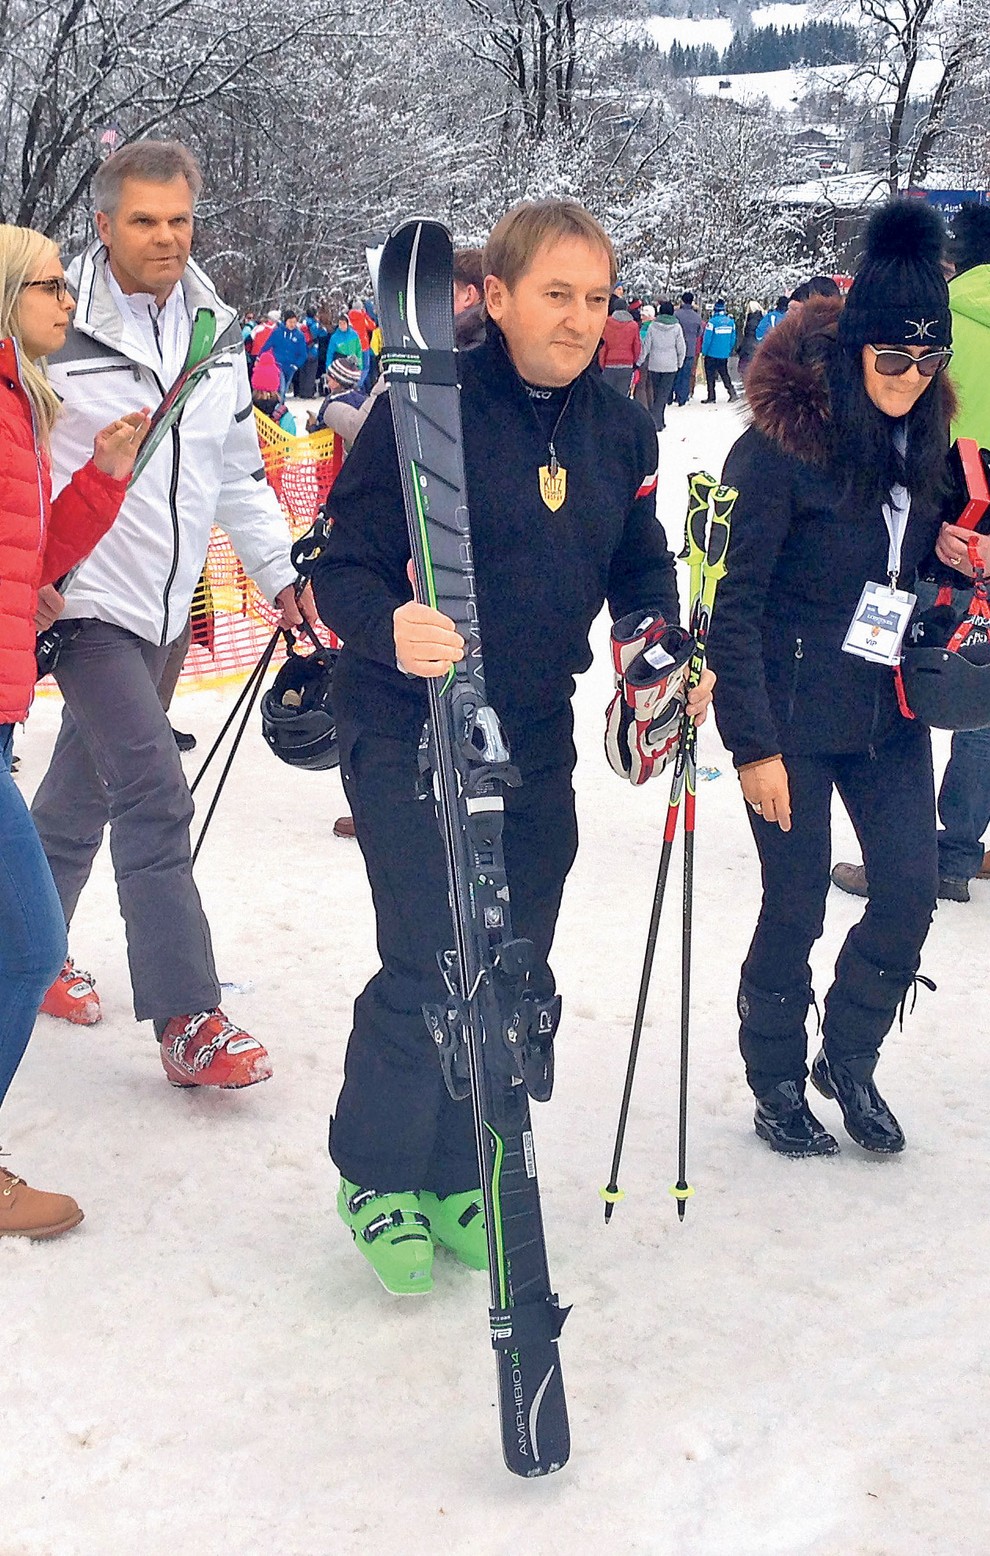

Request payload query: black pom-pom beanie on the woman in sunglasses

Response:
[839,199,953,350]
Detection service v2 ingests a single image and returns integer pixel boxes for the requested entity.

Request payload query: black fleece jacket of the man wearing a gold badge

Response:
[313,325,677,750]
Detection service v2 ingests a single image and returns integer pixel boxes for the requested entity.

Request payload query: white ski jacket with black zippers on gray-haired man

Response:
[48,243,296,644]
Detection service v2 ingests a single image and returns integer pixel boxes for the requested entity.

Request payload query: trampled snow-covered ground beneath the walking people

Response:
[0,403,990,1556]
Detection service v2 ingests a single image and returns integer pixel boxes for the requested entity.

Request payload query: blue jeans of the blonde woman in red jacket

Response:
[0,724,67,1102]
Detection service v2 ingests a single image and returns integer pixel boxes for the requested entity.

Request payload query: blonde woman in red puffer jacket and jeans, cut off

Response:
[0,226,148,1237]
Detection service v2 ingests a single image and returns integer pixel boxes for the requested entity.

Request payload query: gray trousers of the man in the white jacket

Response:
[31,621,219,1021]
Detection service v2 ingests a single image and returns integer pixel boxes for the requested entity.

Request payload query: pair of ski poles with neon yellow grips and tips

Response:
[601,470,739,1223]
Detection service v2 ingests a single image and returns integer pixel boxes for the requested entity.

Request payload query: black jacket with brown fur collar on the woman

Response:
[708,305,948,767]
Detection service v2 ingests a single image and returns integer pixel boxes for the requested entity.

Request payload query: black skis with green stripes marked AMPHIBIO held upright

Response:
[377,221,570,1475]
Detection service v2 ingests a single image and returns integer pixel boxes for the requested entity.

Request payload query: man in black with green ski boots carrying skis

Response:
[314,201,713,1295]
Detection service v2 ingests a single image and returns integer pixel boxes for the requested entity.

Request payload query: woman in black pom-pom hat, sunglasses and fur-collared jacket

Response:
[710,201,951,1156]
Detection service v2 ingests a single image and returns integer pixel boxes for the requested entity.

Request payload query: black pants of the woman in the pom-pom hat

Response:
[739,720,939,1095]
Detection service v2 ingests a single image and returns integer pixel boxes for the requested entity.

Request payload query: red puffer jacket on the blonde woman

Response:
[0,341,128,724]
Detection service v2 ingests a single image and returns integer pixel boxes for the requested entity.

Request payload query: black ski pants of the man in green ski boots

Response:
[330,708,578,1197]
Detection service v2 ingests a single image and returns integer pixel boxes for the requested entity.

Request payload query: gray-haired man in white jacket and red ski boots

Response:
[33,140,316,1088]
